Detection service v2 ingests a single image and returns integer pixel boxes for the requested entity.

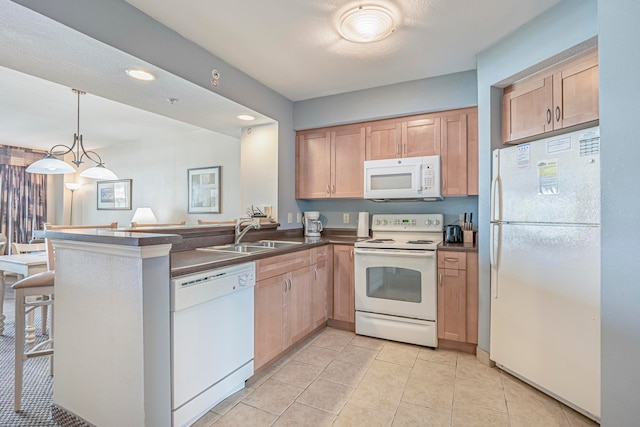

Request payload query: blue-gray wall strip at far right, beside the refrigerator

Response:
[598,0,640,427]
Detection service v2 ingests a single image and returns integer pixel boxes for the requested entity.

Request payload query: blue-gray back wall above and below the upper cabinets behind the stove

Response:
[293,70,478,228]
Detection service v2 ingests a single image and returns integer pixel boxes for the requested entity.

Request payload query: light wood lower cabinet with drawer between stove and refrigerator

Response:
[438,250,478,344]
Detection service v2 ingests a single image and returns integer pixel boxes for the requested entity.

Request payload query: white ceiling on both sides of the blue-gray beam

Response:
[0,0,560,153]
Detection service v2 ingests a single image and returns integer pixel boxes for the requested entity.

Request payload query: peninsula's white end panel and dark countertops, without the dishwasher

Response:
[39,224,355,426]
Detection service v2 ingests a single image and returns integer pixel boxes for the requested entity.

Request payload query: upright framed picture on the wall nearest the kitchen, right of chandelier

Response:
[187,166,222,213]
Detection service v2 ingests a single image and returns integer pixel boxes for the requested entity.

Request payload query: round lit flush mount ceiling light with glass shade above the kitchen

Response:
[340,6,395,43]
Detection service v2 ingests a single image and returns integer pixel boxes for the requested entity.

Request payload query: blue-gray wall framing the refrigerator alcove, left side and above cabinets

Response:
[477,0,597,351]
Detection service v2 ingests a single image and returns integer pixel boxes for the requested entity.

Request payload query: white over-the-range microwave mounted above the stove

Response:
[364,156,442,201]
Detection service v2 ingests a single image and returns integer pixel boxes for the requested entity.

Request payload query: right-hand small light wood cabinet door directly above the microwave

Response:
[402,116,441,157]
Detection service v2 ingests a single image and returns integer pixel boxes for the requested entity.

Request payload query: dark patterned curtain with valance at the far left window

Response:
[0,146,47,252]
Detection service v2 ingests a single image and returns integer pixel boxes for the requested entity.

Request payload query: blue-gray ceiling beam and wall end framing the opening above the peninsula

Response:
[13,0,298,228]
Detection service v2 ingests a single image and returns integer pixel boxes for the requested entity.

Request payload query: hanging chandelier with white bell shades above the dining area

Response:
[27,89,118,180]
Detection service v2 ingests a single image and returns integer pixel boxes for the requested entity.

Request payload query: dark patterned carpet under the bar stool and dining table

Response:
[0,284,56,427]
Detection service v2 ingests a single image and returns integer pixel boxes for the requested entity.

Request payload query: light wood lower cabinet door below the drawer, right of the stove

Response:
[438,268,467,342]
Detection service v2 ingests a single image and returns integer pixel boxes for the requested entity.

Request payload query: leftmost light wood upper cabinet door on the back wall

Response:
[296,132,332,199]
